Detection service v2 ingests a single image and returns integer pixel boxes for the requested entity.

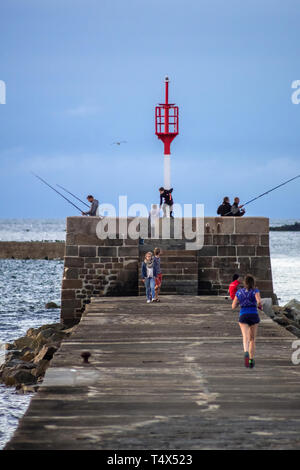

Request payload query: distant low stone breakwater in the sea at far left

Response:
[0,242,65,259]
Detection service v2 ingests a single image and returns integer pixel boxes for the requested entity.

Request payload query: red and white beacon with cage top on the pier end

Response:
[155,77,179,189]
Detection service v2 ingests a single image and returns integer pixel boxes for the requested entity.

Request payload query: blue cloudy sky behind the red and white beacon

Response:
[0,0,300,219]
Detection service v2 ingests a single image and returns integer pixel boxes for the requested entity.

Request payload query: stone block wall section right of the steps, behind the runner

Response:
[198,217,273,297]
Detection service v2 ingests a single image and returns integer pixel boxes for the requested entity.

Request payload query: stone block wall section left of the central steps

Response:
[61,217,139,324]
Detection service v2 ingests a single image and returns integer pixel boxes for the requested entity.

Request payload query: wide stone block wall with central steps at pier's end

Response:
[61,217,273,324]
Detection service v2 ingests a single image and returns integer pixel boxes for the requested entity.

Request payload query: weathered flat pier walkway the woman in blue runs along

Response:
[6,295,300,450]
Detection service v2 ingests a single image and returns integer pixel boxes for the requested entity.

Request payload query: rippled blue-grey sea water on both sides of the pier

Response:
[0,219,300,449]
